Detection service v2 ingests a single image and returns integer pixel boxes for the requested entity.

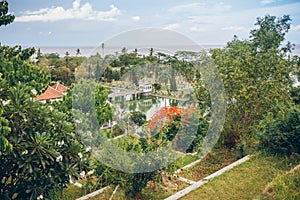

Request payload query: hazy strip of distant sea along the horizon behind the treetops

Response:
[34,44,300,57]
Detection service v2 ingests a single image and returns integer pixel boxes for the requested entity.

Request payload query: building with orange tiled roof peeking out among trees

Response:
[35,82,68,103]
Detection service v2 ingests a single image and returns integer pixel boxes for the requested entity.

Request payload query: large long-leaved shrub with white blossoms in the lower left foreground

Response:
[0,85,87,199]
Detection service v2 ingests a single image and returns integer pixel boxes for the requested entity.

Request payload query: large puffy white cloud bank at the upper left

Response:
[15,0,121,22]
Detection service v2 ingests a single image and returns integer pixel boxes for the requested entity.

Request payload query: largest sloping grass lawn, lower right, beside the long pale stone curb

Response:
[182,155,300,200]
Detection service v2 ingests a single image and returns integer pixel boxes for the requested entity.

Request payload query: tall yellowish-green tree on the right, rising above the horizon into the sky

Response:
[212,15,294,146]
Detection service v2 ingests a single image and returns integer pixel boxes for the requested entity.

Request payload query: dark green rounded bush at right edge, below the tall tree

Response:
[258,107,300,155]
